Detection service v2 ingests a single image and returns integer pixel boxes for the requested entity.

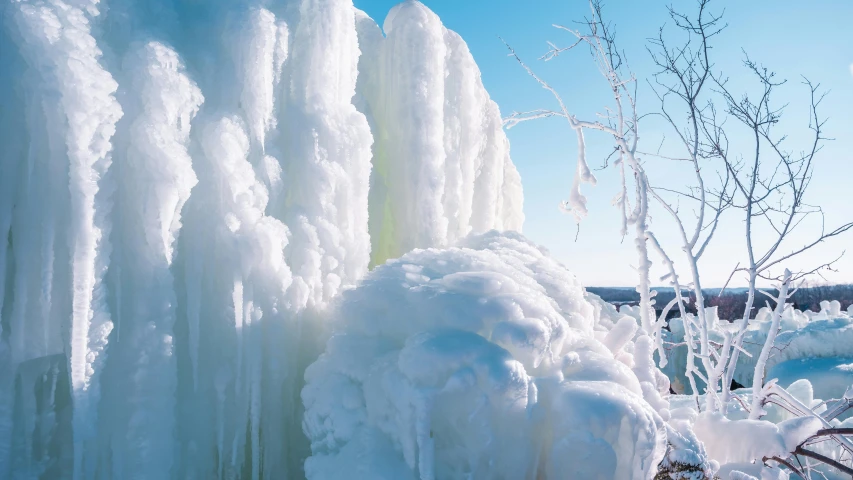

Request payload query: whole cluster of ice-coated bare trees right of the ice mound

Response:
[505,0,853,472]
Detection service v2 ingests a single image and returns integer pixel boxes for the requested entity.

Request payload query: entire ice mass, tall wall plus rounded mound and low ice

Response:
[6,0,853,480]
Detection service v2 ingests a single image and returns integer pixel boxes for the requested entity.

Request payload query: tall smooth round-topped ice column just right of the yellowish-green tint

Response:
[383,2,448,252]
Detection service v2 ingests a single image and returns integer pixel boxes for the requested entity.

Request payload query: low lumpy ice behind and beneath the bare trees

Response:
[665,301,853,480]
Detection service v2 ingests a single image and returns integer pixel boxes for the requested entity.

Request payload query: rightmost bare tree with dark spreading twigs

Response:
[703,57,853,405]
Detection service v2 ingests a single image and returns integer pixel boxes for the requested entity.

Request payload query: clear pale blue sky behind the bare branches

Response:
[354,0,853,287]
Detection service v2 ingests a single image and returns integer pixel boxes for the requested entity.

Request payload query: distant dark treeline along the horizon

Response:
[587,285,853,320]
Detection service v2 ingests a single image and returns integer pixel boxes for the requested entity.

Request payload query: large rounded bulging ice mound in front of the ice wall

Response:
[302,232,666,479]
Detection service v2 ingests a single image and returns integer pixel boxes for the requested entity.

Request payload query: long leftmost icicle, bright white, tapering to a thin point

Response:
[5,0,122,478]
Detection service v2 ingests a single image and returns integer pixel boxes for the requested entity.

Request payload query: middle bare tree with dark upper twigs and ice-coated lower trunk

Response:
[647,0,732,409]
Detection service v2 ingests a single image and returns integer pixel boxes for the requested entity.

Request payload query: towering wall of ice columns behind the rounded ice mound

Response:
[0,0,522,479]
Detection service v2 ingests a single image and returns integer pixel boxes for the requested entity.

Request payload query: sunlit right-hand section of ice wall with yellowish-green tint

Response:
[356,0,524,264]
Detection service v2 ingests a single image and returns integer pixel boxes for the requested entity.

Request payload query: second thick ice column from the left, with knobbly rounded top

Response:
[105,42,203,478]
